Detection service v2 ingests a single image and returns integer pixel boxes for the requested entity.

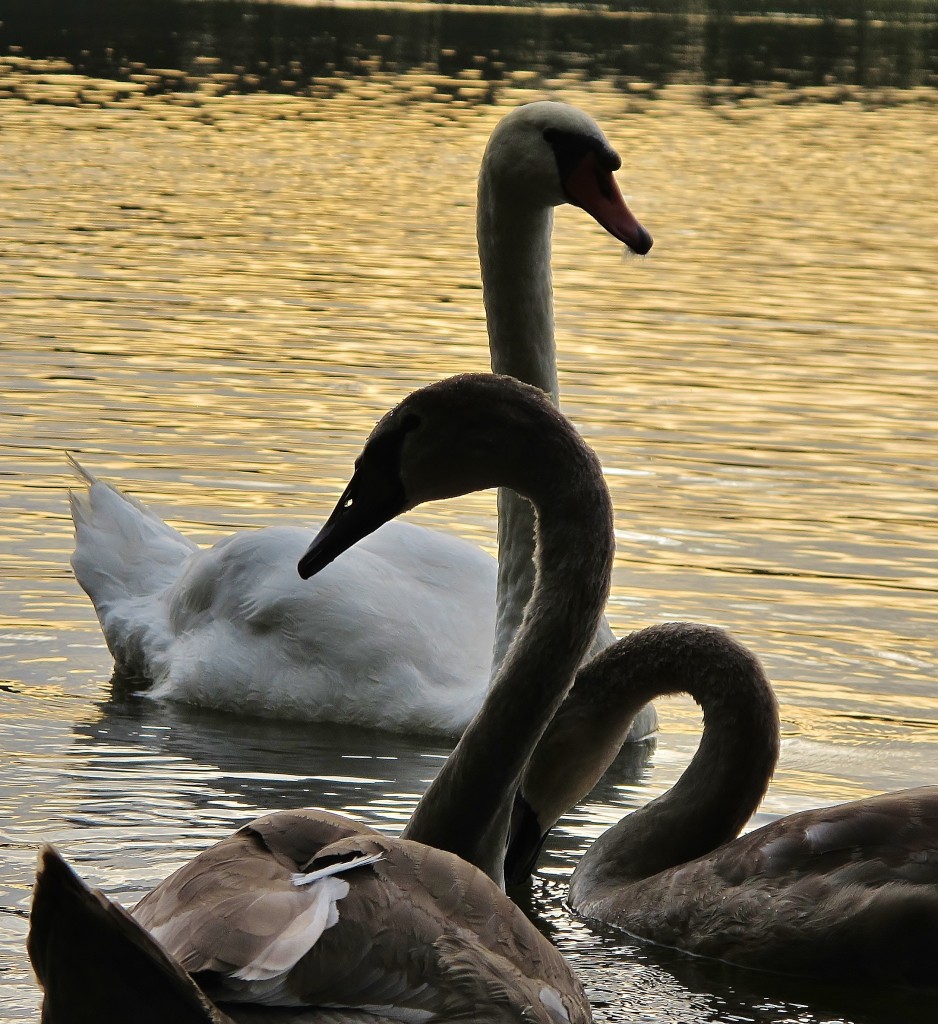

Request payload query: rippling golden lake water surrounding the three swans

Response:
[0,0,938,1024]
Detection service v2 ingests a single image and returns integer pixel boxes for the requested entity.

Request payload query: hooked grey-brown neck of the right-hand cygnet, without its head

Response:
[570,623,778,904]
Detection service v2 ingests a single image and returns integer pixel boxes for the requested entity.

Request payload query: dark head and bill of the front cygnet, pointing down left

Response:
[298,374,573,580]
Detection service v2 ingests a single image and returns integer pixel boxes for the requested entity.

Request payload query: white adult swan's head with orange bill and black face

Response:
[480,100,652,256]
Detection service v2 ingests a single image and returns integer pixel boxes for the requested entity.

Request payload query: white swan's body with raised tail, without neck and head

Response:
[71,464,496,735]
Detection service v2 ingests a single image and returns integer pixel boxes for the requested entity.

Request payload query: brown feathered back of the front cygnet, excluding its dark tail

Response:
[133,811,589,1024]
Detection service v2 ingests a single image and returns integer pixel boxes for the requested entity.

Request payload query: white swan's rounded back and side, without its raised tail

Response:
[151,522,495,736]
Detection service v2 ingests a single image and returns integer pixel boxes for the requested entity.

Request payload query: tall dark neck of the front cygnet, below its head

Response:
[403,419,613,885]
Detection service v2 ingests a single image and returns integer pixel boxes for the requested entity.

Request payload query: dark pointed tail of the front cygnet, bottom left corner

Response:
[27,846,231,1024]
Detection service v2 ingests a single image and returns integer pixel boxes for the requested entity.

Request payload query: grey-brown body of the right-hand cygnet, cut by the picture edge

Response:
[570,786,938,986]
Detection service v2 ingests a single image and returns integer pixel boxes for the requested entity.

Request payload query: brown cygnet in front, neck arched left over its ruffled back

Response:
[29,375,613,1024]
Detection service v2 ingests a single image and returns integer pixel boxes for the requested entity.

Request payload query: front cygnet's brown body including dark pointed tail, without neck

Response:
[30,810,577,1024]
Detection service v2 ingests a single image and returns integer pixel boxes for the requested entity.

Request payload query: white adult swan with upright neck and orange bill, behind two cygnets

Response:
[71,102,654,735]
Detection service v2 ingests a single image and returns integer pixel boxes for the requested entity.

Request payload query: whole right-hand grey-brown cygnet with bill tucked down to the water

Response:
[507,623,938,986]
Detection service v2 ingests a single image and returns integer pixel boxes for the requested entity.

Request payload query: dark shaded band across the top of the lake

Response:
[0,0,938,93]
